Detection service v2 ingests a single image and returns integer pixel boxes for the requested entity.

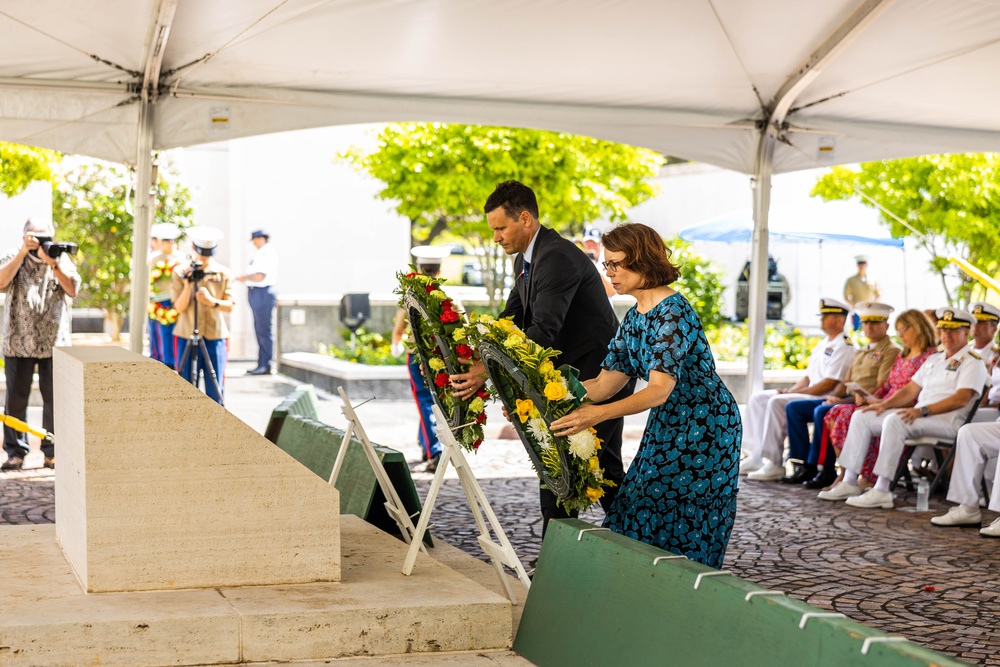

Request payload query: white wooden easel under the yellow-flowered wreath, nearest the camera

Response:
[403,405,531,604]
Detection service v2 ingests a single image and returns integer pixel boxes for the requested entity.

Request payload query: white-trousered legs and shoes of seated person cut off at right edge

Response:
[931,422,1000,537]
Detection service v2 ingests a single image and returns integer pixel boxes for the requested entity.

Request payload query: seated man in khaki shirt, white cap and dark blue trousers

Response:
[781,301,901,489]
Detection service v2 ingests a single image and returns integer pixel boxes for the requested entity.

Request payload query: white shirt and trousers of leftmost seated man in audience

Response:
[744,334,855,465]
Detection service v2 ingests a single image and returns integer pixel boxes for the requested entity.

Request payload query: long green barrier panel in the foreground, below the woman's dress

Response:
[514,519,966,667]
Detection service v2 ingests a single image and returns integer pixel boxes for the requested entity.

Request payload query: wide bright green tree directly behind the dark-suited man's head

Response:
[338,123,664,307]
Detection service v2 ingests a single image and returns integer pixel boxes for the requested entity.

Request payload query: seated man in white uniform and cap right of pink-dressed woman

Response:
[819,308,986,509]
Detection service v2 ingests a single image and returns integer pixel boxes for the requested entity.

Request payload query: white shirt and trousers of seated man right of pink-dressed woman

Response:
[840,343,986,479]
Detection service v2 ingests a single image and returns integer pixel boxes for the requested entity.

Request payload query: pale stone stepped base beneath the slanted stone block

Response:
[0,516,512,667]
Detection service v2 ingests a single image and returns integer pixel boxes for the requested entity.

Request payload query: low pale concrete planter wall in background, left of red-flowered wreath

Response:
[278,352,411,400]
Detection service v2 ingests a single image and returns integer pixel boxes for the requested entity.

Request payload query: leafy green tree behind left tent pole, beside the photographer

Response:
[52,158,192,340]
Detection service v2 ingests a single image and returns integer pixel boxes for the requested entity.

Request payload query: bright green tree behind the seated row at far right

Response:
[812,153,1000,307]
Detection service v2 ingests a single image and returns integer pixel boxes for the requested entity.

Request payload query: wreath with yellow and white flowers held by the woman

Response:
[464,315,615,512]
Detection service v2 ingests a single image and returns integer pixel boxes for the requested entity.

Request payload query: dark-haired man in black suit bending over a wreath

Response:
[451,181,635,534]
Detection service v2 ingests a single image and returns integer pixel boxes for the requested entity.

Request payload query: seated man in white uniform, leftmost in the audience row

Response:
[740,299,855,481]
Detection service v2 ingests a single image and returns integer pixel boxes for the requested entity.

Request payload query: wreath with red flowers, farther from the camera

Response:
[395,266,490,451]
